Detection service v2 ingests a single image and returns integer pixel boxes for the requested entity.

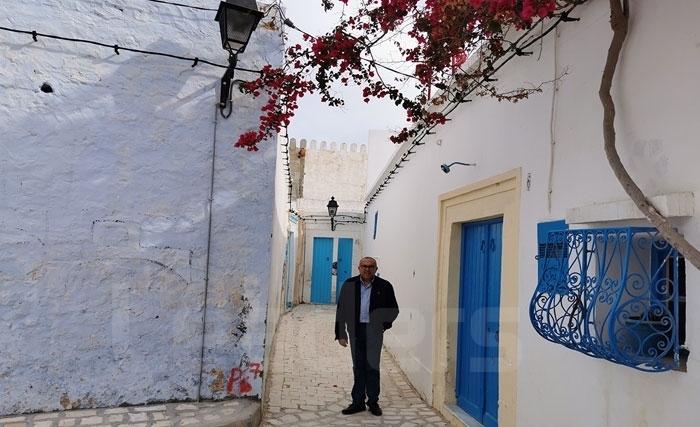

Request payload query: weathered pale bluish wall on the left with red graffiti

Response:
[0,0,281,414]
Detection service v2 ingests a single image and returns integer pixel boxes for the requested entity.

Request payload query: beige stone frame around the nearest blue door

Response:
[433,168,521,426]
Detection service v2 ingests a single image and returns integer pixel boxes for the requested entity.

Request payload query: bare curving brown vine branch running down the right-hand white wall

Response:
[598,0,700,269]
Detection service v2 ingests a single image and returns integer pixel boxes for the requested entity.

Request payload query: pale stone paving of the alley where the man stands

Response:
[261,304,448,427]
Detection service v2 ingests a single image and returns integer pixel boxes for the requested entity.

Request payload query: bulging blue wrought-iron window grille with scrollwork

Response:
[530,227,680,372]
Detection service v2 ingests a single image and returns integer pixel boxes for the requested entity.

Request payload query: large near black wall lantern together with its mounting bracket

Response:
[215,0,264,118]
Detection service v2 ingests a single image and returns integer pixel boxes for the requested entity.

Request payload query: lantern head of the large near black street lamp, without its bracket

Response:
[216,0,264,55]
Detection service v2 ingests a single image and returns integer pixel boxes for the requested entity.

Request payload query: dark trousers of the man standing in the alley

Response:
[350,323,384,405]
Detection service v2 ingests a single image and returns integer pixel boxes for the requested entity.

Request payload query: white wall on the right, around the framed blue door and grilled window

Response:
[365,0,700,427]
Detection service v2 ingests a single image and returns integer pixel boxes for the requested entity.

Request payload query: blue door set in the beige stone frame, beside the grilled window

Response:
[456,218,503,427]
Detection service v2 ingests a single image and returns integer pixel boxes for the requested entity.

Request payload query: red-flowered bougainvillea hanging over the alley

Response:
[236,0,585,150]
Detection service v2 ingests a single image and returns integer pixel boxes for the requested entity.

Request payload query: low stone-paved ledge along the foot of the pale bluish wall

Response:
[0,399,260,427]
